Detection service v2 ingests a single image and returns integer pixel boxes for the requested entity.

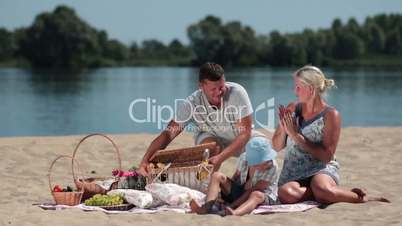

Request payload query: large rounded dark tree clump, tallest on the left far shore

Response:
[19,6,101,69]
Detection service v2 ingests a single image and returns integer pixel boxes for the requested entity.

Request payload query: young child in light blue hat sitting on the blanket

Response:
[190,137,278,216]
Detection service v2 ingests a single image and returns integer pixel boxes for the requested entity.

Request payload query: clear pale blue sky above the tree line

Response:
[0,0,402,44]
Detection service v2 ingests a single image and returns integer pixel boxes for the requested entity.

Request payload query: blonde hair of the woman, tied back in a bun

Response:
[294,65,336,97]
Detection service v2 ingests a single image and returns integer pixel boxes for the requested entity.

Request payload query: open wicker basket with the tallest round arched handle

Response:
[72,133,121,200]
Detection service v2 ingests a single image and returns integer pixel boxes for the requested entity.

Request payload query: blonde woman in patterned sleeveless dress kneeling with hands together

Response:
[272,66,388,204]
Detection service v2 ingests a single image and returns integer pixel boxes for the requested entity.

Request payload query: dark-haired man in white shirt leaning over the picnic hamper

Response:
[139,63,263,175]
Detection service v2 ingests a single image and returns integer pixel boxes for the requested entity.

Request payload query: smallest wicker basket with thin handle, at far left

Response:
[48,155,84,206]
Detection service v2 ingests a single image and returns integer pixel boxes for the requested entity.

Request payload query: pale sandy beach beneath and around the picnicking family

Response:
[0,127,402,226]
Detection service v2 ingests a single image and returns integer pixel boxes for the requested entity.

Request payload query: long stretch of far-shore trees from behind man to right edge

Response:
[187,14,402,66]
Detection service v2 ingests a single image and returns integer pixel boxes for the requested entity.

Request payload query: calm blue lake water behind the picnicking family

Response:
[0,67,402,136]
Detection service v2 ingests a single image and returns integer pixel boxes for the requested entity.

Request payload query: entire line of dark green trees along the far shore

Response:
[0,6,402,69]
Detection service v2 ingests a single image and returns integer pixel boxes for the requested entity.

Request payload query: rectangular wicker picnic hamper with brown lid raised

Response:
[147,142,218,192]
